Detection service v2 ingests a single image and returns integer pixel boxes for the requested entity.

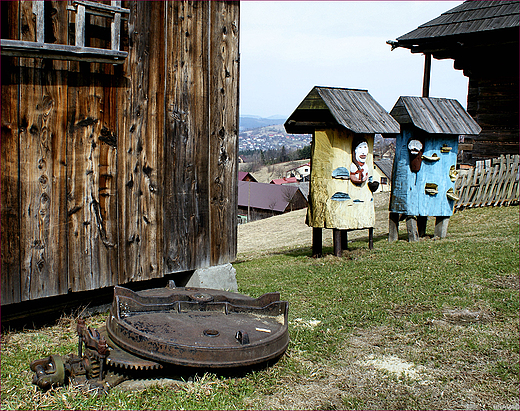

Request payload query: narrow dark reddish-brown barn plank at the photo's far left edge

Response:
[0,1,21,304]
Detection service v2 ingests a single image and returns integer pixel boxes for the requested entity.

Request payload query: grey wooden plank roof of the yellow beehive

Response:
[284,86,399,134]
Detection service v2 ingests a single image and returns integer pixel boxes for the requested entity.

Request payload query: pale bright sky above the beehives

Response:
[239,0,468,118]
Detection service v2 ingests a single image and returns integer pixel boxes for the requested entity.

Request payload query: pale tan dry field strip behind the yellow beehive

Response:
[237,192,390,261]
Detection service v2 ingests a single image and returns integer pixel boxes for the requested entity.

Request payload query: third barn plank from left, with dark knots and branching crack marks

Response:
[67,4,118,291]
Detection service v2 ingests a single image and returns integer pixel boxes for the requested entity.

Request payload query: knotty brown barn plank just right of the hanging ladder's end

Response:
[118,2,166,283]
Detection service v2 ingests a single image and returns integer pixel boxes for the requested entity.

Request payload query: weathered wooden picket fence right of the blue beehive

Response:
[455,155,519,211]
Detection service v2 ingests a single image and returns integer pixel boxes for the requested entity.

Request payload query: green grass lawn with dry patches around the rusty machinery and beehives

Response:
[1,207,519,410]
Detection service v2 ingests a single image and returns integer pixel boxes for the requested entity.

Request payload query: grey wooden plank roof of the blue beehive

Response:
[390,97,481,135]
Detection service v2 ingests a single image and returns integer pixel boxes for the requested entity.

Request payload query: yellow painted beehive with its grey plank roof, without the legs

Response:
[285,87,399,230]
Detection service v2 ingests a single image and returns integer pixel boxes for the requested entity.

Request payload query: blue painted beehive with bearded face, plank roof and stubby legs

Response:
[388,97,481,241]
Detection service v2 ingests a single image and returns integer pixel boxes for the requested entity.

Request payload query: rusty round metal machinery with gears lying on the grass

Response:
[31,286,289,390]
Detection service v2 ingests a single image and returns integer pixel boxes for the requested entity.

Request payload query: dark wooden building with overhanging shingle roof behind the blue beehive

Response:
[389,0,520,164]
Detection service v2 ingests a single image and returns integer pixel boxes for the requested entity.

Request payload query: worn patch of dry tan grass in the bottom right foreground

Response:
[263,324,519,410]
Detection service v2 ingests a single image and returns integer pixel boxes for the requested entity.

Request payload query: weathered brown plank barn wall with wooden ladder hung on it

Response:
[1,1,239,306]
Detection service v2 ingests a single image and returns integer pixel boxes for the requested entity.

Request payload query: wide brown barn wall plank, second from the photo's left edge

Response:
[20,4,67,300]
